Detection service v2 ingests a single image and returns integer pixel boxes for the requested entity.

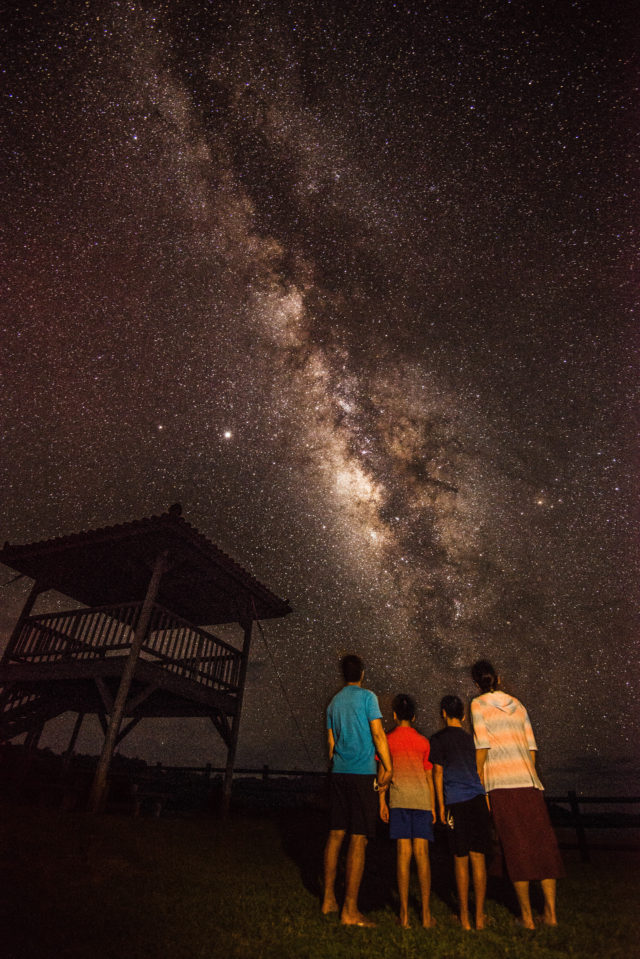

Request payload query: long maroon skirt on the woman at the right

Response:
[489,788,564,882]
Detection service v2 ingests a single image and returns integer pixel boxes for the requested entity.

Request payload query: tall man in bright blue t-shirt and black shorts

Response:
[322,656,392,926]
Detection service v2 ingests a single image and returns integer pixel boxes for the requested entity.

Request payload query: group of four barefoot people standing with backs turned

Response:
[322,655,564,929]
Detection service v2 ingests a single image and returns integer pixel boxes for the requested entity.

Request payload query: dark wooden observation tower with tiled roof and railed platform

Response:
[0,505,291,809]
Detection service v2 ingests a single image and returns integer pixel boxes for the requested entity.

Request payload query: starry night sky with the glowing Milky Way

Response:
[0,0,640,793]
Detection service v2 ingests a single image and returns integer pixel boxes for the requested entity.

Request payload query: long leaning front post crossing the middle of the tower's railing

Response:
[89,551,169,812]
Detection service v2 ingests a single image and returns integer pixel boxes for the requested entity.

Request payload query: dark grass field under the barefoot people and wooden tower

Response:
[0,804,640,959]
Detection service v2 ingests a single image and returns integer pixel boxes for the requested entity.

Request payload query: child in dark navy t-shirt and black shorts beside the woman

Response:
[430,696,491,929]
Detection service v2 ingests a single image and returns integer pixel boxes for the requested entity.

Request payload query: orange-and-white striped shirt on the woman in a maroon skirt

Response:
[471,690,543,792]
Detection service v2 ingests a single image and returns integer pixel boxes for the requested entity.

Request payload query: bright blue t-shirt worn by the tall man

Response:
[327,686,382,776]
